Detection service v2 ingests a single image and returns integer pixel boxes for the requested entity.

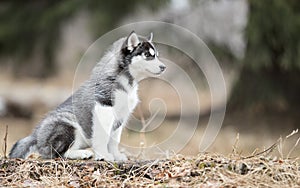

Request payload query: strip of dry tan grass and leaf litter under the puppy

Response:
[0,153,300,187]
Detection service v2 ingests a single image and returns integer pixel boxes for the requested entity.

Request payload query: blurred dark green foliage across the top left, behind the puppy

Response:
[0,0,168,74]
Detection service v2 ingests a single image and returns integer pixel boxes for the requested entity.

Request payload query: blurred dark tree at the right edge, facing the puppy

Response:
[228,0,300,115]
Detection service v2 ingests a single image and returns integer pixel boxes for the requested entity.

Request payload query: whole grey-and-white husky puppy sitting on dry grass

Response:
[9,31,166,161]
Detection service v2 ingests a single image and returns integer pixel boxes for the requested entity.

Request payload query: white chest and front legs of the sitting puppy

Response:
[92,81,139,160]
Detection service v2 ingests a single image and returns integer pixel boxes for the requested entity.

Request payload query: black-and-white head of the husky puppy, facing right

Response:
[122,31,166,80]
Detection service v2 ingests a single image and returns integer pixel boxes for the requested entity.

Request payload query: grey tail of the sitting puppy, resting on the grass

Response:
[9,135,37,159]
